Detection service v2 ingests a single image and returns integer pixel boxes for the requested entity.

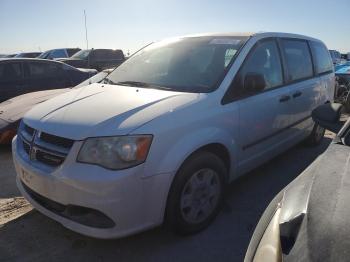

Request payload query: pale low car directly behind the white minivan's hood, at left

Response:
[0,69,113,144]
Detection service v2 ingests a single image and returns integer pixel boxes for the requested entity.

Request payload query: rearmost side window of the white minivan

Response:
[310,42,333,74]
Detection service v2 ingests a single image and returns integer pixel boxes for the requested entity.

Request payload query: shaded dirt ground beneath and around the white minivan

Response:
[0,134,332,261]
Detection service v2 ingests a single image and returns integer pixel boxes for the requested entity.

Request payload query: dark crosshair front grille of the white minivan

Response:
[19,124,74,167]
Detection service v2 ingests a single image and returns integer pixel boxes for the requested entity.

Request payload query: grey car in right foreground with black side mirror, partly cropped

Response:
[244,104,350,262]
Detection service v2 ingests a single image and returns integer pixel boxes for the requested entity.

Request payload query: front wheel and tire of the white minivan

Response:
[166,151,227,235]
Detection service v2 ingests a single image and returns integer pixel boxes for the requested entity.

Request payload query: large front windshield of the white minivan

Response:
[105,36,247,93]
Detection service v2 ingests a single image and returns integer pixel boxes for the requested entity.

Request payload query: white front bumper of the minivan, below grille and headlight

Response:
[12,138,172,238]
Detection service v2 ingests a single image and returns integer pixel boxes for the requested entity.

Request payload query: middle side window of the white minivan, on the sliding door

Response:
[282,39,313,82]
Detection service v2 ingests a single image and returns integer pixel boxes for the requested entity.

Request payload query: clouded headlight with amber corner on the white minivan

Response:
[77,135,153,170]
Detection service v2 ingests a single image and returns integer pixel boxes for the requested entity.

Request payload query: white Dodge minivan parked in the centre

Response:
[12,33,334,238]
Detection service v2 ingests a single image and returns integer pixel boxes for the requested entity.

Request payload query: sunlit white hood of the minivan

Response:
[24,84,199,140]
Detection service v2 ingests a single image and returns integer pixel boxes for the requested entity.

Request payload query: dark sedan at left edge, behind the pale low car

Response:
[0,58,96,102]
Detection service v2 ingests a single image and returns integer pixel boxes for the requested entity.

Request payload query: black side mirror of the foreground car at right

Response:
[311,103,343,134]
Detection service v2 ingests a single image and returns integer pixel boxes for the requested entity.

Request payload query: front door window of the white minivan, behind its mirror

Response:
[238,40,283,94]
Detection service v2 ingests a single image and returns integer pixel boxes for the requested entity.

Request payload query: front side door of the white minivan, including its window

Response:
[235,39,293,173]
